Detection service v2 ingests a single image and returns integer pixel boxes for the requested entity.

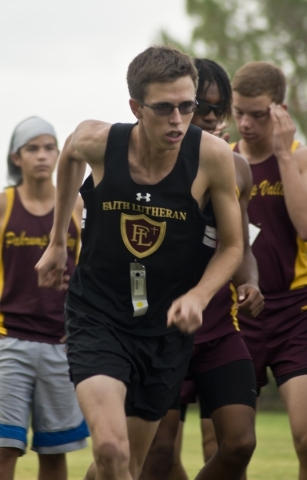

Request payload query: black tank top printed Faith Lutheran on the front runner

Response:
[68,124,214,335]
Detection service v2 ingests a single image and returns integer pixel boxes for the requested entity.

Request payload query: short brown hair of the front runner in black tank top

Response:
[127,45,198,102]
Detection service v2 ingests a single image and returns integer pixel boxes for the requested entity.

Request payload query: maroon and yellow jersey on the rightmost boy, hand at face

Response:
[234,142,307,295]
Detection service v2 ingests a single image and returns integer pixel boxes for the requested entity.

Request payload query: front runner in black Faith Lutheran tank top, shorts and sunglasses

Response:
[37,46,242,480]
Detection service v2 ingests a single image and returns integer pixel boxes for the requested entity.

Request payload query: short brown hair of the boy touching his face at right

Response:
[232,62,286,104]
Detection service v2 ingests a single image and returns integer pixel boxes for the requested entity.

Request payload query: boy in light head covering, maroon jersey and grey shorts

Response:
[0,117,88,480]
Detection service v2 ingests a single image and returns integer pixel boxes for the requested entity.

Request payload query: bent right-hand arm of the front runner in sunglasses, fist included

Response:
[167,137,243,333]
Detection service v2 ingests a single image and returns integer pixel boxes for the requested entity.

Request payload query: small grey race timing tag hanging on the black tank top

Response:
[130,262,148,317]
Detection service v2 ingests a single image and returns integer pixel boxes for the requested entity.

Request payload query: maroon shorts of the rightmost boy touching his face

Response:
[239,288,307,387]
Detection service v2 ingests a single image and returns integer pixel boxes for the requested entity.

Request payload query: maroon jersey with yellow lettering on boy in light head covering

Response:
[0,188,80,344]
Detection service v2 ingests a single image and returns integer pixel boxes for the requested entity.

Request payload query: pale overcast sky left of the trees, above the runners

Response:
[0,0,192,189]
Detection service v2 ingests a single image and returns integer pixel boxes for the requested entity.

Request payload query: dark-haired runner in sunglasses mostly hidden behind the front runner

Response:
[141,59,263,480]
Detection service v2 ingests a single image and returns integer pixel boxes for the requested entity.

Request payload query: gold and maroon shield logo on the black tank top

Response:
[120,213,166,258]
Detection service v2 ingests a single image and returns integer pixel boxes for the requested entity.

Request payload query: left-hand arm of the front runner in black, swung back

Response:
[36,121,108,290]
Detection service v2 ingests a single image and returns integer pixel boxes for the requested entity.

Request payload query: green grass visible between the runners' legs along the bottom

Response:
[15,408,297,480]
